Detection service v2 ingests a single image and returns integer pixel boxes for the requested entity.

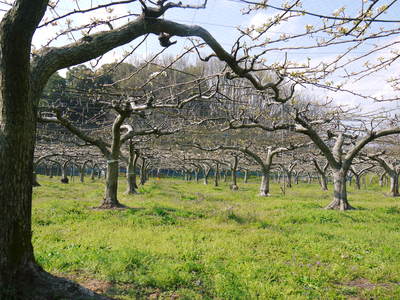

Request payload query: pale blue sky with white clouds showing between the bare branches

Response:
[0,0,400,110]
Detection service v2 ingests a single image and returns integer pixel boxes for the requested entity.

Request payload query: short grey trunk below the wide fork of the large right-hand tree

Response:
[326,169,354,210]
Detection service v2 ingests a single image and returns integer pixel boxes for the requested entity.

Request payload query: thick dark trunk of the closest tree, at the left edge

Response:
[0,0,111,300]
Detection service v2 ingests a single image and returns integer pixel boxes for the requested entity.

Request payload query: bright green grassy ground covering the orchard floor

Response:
[33,177,400,299]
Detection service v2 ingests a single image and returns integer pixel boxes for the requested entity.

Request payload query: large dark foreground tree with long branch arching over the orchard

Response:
[0,0,290,299]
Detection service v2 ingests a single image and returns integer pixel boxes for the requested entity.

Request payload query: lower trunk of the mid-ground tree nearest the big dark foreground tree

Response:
[99,158,124,209]
